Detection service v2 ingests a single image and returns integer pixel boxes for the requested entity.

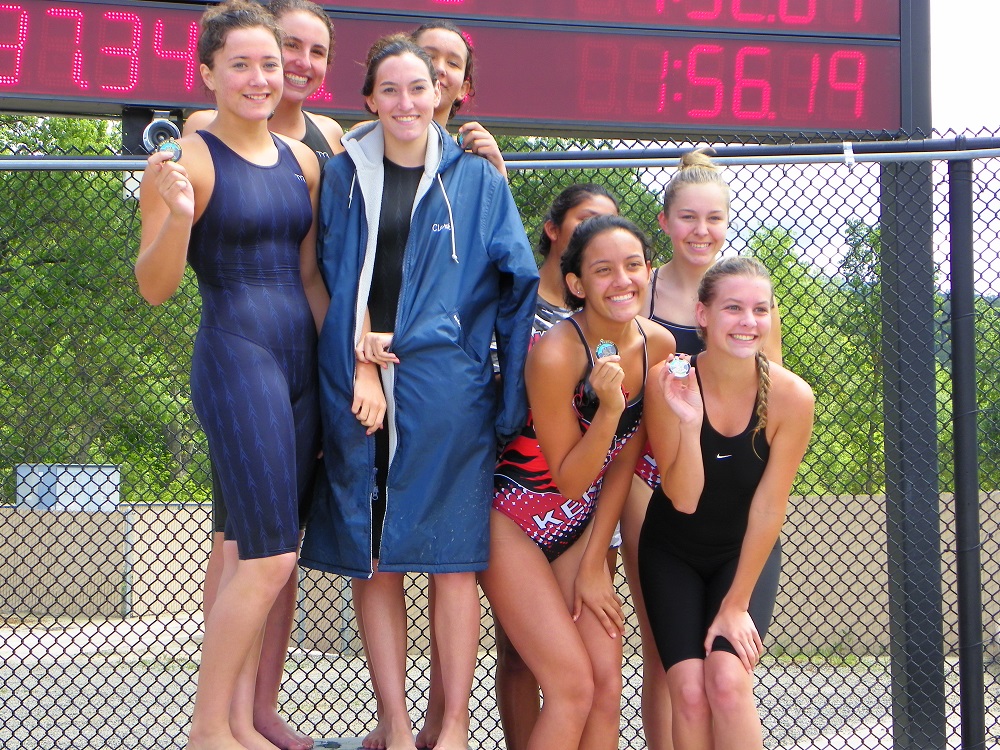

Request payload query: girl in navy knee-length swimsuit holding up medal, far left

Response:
[135,0,328,750]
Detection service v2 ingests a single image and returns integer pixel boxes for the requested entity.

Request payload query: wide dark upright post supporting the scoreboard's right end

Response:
[881,162,946,750]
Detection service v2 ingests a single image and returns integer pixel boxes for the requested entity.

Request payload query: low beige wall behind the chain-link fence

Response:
[0,495,1000,652]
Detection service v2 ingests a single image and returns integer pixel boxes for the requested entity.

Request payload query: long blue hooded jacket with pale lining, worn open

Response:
[301,123,538,578]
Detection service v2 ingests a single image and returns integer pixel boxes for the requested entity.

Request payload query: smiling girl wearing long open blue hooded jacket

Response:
[302,35,538,750]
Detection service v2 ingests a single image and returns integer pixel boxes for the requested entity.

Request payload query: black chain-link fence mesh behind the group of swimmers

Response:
[0,117,1000,750]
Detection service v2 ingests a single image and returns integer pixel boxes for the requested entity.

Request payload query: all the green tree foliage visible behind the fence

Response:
[0,116,1000,501]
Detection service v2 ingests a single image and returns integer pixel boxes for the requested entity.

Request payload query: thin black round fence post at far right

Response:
[948,148,986,750]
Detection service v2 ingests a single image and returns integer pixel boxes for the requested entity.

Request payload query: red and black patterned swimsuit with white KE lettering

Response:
[493,318,647,562]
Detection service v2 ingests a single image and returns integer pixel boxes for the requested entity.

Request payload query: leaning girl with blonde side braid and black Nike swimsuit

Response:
[639,257,813,750]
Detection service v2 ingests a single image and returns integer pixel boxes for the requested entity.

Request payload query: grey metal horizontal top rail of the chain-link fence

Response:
[0,136,1000,172]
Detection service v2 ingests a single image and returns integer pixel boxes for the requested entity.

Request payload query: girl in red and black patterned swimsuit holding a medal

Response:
[480,216,674,748]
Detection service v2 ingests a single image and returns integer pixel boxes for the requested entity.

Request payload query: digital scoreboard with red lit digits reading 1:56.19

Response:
[0,0,910,136]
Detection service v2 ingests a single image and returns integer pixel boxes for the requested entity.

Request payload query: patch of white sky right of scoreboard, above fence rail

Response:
[931,0,1000,132]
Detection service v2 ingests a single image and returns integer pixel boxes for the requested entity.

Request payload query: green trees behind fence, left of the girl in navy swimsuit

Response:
[0,116,203,501]
